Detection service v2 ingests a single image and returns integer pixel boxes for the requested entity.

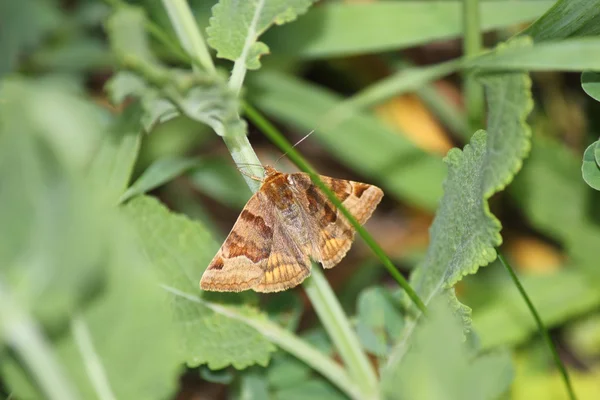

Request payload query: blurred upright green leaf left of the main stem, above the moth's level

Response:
[88,104,142,205]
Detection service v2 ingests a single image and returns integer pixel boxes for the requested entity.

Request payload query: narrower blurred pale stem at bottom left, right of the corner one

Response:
[71,315,116,400]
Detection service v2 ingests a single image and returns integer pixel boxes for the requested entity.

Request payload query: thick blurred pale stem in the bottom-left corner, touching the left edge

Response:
[0,282,79,400]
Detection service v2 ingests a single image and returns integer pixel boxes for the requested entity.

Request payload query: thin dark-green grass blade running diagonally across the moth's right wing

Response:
[244,103,427,313]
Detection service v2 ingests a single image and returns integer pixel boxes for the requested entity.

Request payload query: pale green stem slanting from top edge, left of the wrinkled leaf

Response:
[163,0,216,74]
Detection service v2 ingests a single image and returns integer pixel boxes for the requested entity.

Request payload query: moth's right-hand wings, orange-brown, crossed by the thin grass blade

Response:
[291,173,383,268]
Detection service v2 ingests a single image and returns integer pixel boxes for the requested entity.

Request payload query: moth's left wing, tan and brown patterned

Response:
[200,193,274,292]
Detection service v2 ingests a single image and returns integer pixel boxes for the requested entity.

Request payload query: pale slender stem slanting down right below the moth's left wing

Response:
[162,285,364,400]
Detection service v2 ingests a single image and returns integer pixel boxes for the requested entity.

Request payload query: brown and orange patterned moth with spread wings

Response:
[200,166,383,292]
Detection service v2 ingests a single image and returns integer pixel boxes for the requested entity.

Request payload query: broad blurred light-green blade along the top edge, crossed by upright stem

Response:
[265,1,554,58]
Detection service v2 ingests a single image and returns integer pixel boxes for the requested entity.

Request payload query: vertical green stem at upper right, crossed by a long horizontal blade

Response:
[463,0,485,132]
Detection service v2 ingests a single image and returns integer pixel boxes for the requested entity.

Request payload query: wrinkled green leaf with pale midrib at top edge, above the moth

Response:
[206,0,315,69]
